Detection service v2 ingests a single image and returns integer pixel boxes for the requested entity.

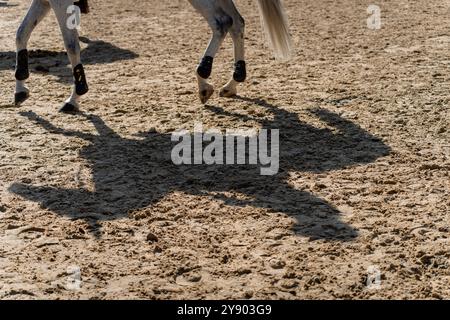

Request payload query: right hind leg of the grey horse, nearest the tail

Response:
[220,0,247,97]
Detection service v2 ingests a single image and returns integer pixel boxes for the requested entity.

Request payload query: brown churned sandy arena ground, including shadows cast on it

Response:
[0,0,450,299]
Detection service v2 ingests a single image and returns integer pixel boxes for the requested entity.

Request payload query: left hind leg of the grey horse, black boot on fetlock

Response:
[189,0,233,103]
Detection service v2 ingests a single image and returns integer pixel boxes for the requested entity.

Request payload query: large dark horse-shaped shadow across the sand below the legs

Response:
[9,98,390,241]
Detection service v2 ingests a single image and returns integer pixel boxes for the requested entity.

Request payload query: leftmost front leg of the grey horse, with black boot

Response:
[14,0,50,106]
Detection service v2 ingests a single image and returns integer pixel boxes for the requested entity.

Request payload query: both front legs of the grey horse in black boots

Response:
[14,0,89,112]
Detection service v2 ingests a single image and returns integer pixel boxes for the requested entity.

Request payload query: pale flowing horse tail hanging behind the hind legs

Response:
[258,0,292,60]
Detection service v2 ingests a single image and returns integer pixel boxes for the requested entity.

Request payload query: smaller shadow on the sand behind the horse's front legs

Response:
[0,37,139,83]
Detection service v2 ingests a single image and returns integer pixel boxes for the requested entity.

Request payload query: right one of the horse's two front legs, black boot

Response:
[49,0,89,112]
